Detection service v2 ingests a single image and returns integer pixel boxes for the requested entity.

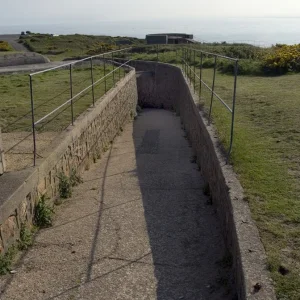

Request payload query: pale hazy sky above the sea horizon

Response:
[0,0,300,24]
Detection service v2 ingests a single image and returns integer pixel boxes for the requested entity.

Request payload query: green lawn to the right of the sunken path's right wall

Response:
[188,69,300,300]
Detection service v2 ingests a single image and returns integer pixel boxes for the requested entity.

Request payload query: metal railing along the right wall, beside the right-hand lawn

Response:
[182,47,239,163]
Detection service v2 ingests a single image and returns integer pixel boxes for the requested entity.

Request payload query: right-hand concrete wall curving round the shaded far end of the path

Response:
[135,62,276,300]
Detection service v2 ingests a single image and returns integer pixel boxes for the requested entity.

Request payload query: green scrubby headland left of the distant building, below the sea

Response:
[20,34,144,61]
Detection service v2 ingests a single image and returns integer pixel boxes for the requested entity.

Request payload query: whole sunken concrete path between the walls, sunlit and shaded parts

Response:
[0,110,233,300]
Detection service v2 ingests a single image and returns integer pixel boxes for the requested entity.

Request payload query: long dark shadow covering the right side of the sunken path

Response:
[133,109,233,300]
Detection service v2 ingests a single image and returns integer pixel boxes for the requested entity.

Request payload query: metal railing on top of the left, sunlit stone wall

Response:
[29,48,133,166]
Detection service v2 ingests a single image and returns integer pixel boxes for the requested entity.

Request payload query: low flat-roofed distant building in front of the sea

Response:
[146,33,196,45]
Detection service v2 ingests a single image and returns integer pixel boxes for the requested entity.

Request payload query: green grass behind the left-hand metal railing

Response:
[0,65,124,132]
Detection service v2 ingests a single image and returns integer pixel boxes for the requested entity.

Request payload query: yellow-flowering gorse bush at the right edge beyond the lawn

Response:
[263,44,300,73]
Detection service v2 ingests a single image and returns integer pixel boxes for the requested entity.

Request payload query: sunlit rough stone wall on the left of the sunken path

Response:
[0,71,137,253]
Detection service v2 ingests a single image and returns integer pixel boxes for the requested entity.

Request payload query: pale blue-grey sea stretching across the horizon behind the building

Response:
[0,17,300,47]
